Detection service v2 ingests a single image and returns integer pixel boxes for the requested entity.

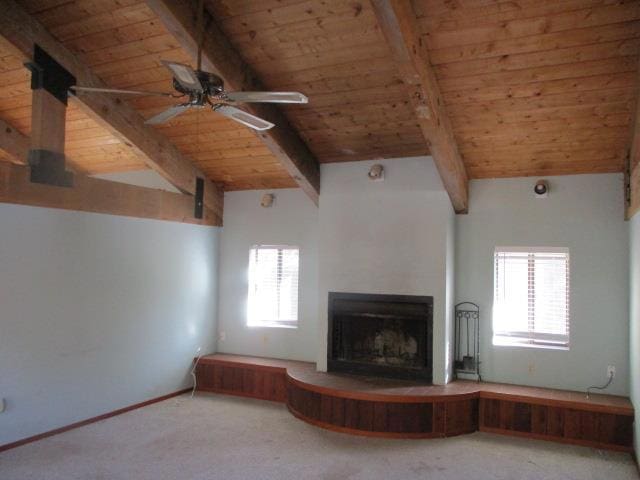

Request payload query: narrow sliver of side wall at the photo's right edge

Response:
[629,213,640,458]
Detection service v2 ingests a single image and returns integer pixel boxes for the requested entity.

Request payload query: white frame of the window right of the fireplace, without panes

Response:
[491,246,571,350]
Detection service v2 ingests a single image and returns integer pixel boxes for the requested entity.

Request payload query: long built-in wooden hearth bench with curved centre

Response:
[196,354,634,451]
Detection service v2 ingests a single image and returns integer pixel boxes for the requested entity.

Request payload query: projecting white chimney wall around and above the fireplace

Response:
[318,157,453,383]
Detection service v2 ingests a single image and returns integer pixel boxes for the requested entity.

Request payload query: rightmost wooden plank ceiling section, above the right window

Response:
[414,0,640,178]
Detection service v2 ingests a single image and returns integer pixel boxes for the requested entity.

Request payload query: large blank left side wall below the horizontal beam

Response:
[0,205,218,445]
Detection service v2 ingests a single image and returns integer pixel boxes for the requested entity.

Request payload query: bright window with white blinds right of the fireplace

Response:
[493,247,569,349]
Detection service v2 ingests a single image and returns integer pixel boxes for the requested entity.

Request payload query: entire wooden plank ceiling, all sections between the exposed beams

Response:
[0,0,640,190]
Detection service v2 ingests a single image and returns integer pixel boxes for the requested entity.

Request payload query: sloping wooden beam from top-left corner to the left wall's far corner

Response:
[0,0,223,224]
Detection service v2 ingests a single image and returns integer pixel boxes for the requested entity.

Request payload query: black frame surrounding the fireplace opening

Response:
[327,292,433,383]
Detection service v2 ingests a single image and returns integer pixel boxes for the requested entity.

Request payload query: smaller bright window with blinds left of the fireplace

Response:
[247,245,299,327]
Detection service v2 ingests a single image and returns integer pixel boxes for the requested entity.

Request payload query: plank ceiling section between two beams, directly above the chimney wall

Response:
[206,0,428,163]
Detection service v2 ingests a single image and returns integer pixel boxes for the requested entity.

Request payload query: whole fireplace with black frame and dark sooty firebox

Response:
[327,292,433,383]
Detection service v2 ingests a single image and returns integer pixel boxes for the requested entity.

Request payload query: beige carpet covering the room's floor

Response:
[0,394,638,480]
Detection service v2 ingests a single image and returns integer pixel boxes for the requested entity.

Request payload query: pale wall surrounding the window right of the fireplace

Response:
[456,174,629,394]
